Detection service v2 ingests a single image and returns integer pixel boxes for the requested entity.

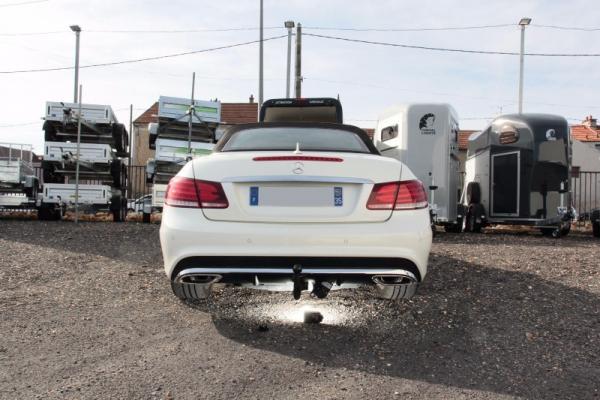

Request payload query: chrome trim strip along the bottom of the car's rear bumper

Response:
[175,267,417,282]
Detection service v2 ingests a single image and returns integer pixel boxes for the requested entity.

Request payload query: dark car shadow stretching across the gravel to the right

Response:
[192,255,600,398]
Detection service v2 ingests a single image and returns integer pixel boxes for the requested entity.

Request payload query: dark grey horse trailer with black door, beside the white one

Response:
[461,114,576,237]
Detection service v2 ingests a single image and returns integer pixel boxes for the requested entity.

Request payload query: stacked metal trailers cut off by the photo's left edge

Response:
[0,143,39,210]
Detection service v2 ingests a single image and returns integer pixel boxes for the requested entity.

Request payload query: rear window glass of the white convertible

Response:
[221,127,371,153]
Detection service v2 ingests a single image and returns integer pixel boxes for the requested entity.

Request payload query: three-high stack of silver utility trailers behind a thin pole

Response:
[38,102,129,222]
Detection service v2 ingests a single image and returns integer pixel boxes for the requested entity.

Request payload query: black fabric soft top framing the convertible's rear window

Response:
[214,122,380,155]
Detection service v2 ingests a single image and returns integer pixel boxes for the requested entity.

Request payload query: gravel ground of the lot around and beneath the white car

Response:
[0,220,600,399]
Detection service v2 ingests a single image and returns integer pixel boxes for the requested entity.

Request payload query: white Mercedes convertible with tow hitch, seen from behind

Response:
[160,123,432,299]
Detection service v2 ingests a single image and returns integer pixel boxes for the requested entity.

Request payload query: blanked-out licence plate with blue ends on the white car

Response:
[249,186,344,207]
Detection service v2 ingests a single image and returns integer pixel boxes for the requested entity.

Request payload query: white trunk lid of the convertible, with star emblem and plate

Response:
[194,151,402,223]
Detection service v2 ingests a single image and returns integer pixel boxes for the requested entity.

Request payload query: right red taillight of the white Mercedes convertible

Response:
[367,180,427,210]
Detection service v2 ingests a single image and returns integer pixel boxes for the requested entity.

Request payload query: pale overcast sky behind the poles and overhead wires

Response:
[0,0,600,152]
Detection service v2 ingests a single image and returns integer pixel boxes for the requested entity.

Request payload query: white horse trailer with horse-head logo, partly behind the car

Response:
[373,103,462,231]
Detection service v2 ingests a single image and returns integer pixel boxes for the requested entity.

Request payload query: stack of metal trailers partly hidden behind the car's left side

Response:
[143,96,221,222]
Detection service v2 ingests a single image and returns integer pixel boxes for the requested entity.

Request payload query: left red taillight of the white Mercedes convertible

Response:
[165,176,229,208]
